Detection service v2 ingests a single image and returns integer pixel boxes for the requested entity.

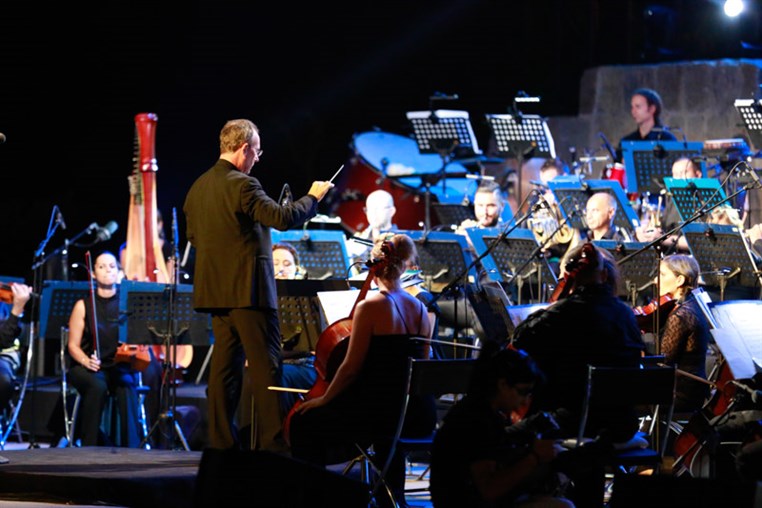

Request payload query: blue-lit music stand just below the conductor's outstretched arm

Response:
[270,229,350,280]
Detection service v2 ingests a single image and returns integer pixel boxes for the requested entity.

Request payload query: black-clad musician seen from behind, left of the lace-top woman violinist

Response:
[513,243,645,442]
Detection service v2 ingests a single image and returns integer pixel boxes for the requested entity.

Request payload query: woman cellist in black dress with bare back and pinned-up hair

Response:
[290,234,435,499]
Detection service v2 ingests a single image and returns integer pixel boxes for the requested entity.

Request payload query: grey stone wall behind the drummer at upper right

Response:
[548,60,762,161]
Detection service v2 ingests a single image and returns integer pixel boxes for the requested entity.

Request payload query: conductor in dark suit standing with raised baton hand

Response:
[183,119,333,452]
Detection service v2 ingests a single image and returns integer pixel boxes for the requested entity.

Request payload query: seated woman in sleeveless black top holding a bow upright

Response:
[68,252,140,448]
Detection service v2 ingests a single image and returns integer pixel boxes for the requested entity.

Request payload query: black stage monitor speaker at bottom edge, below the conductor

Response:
[194,448,370,508]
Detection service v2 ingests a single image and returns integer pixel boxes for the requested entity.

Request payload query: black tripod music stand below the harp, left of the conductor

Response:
[119,281,212,451]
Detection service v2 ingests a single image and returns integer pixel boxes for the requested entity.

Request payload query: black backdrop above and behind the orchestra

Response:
[0,0,762,283]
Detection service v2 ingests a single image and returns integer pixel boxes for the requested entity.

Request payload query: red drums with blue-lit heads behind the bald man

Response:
[331,131,478,231]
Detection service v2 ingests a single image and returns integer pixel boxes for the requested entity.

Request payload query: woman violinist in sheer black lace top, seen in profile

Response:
[659,254,711,412]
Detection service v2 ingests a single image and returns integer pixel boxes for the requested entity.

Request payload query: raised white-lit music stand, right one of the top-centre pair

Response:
[485,111,556,203]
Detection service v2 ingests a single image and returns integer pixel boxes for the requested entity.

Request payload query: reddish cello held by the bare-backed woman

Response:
[283,262,383,443]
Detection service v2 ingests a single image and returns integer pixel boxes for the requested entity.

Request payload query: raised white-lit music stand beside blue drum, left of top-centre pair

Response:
[407,109,481,231]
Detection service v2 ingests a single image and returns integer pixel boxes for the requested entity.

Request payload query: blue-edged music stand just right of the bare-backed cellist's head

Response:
[399,231,476,292]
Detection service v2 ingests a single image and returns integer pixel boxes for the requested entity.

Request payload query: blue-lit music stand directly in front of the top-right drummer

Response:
[622,141,706,194]
